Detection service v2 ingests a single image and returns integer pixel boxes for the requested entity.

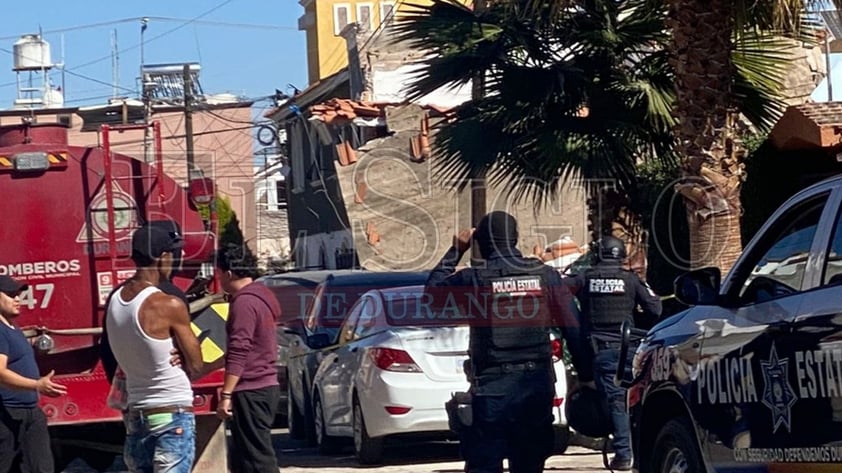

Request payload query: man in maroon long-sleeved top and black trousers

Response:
[216,245,281,473]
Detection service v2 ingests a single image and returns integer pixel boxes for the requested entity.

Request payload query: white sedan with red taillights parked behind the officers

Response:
[312,286,568,464]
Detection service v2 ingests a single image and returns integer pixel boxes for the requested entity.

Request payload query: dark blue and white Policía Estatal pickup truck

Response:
[616,177,842,473]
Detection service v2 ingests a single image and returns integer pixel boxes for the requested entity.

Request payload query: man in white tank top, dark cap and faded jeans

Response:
[106,224,204,473]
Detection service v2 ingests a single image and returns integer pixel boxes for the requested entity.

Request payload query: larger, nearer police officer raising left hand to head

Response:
[426,212,593,473]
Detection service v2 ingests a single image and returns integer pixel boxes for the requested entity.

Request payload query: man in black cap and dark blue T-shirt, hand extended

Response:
[0,276,67,473]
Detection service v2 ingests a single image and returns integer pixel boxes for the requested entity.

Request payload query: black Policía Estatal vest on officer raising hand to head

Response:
[469,261,552,371]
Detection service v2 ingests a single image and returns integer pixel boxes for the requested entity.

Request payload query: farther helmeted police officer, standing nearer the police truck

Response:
[565,236,661,471]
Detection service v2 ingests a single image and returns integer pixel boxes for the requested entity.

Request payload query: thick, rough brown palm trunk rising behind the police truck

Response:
[669,0,744,272]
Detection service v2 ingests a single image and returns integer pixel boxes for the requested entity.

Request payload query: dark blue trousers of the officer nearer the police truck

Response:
[594,348,631,459]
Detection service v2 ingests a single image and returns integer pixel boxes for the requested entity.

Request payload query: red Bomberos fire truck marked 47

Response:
[0,122,225,471]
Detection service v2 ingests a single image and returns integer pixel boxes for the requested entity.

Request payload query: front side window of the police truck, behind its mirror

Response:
[731,194,829,304]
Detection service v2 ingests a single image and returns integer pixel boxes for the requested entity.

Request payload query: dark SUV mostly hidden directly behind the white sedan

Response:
[286,271,429,446]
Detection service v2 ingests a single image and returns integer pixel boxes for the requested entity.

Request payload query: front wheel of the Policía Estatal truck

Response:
[652,419,705,473]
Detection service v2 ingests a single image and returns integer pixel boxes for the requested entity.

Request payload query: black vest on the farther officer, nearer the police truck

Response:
[578,266,635,333]
